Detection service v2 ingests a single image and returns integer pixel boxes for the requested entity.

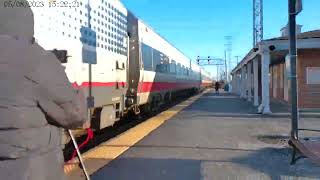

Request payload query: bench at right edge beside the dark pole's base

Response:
[289,129,320,166]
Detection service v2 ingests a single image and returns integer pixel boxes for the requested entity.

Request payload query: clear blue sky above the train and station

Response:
[122,0,320,76]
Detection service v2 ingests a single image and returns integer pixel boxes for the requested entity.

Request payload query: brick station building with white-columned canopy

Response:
[231,25,320,114]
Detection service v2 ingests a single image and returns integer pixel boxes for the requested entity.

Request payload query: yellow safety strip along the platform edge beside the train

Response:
[64,90,209,174]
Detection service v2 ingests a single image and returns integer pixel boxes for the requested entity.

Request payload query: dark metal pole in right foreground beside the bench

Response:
[288,0,302,139]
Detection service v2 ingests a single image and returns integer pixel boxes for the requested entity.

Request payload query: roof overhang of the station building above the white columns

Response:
[231,30,320,74]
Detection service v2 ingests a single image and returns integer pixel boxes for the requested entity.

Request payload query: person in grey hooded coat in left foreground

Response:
[0,0,87,180]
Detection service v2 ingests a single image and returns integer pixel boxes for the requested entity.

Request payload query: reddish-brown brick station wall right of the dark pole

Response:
[297,49,320,108]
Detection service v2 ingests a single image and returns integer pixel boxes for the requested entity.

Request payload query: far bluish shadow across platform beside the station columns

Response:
[183,92,320,118]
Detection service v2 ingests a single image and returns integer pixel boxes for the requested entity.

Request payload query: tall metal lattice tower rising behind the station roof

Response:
[253,0,263,47]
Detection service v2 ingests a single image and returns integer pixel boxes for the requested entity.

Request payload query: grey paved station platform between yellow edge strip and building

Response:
[72,91,320,180]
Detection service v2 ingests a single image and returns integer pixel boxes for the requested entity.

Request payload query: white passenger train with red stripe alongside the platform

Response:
[28,0,212,129]
